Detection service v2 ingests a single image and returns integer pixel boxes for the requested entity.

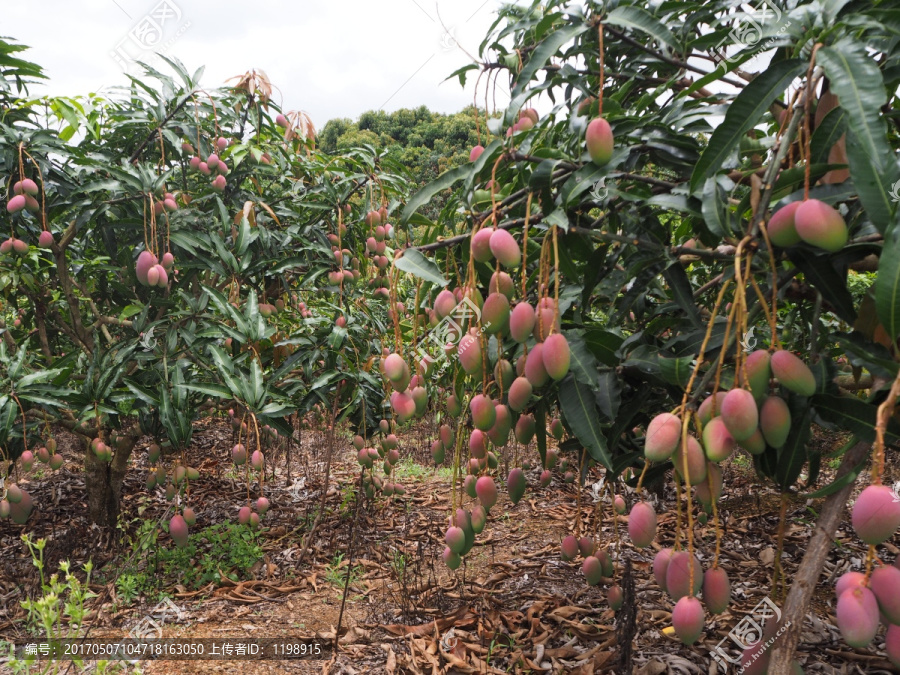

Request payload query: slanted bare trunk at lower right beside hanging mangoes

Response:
[768,441,872,675]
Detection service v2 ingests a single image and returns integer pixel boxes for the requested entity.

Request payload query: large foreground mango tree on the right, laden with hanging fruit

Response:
[384,0,900,673]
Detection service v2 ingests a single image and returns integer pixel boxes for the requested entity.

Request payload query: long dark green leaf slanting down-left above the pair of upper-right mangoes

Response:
[691,59,807,192]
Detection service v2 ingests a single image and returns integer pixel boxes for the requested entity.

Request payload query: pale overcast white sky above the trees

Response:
[0,0,508,129]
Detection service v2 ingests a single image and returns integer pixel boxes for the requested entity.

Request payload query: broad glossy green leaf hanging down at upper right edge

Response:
[816,43,900,232]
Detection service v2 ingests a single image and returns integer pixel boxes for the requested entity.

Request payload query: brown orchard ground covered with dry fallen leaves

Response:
[0,417,900,675]
